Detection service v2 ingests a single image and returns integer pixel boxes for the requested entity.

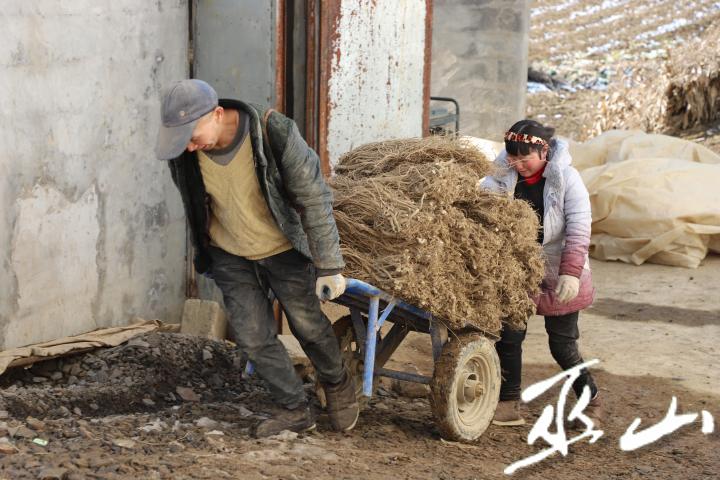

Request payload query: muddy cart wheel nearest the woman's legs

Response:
[430,334,500,442]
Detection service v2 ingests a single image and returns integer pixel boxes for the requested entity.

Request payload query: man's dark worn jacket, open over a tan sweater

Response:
[169,99,345,276]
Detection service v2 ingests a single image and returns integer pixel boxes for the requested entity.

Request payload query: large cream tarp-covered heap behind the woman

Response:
[571,131,720,268]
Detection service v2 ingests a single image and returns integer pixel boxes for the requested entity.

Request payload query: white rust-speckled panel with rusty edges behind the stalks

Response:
[327,0,427,165]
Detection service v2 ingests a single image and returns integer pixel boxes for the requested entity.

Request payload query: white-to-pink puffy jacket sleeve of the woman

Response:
[560,167,592,278]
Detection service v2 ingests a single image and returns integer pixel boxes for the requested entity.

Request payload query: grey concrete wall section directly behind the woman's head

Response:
[431,0,530,140]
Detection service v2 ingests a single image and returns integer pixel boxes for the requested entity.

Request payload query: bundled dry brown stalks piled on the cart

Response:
[330,137,544,335]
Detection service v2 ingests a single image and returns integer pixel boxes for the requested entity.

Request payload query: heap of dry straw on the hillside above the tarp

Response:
[594,25,720,134]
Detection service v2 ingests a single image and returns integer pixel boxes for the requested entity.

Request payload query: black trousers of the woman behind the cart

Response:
[495,312,597,400]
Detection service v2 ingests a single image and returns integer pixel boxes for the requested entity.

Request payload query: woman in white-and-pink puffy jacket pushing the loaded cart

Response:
[482,120,601,426]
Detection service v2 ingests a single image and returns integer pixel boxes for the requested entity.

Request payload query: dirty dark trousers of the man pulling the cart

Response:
[210,247,343,408]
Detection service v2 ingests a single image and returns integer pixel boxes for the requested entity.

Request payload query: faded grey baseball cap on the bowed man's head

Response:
[155,79,218,160]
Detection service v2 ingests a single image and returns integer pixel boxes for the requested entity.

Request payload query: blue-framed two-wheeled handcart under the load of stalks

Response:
[333,278,500,442]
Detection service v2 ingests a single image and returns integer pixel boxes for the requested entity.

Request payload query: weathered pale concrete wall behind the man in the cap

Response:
[0,0,188,349]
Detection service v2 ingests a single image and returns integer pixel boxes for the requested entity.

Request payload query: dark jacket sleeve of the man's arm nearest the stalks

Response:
[270,113,345,275]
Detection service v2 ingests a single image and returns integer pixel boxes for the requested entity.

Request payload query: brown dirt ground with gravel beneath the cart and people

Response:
[0,256,720,479]
